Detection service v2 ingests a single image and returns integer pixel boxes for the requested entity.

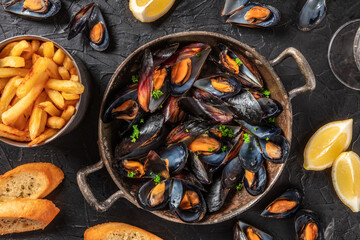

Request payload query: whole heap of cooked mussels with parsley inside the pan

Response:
[102,43,289,222]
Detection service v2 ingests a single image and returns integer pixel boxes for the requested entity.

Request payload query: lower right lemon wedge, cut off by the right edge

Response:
[331,152,360,212]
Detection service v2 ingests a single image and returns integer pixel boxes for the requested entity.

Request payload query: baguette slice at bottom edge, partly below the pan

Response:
[84,222,162,240]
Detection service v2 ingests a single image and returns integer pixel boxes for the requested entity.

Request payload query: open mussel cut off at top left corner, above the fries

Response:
[2,0,61,20]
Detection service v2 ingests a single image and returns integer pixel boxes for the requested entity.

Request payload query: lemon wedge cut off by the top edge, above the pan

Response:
[129,0,175,22]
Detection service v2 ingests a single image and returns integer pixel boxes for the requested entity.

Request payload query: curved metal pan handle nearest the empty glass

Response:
[270,47,316,100]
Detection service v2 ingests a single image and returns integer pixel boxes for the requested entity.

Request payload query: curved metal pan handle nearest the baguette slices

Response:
[76,161,124,212]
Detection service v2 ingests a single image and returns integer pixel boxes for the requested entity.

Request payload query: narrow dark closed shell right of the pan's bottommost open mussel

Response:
[205,177,230,213]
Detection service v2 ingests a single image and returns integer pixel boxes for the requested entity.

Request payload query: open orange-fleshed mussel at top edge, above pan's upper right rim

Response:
[221,0,281,28]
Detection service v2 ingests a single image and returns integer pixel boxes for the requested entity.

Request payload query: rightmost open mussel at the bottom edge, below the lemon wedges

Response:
[295,209,325,240]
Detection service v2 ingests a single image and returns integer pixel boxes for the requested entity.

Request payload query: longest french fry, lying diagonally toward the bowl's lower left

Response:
[1,75,49,125]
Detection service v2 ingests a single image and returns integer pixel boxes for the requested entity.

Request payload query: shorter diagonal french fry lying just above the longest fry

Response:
[16,58,49,98]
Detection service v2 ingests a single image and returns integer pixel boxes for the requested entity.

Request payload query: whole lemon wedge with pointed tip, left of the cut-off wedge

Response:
[304,119,353,171]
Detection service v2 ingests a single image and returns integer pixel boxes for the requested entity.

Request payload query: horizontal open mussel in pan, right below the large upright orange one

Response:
[194,75,241,98]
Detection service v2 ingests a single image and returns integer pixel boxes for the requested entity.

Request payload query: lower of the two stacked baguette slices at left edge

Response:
[0,198,60,235]
